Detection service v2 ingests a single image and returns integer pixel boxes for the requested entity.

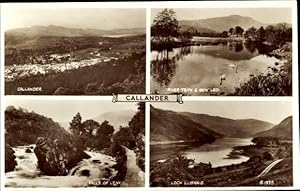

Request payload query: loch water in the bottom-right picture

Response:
[151,138,253,167]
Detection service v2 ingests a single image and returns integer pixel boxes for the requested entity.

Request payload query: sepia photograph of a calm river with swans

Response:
[151,7,292,96]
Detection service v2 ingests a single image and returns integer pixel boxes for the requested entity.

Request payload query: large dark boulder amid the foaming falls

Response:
[34,137,90,176]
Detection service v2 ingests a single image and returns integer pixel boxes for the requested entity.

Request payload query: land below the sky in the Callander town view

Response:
[5,25,145,95]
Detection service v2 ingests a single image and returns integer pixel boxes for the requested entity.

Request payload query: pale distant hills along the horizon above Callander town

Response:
[5,25,146,38]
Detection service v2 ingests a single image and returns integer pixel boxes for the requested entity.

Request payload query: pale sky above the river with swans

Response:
[151,8,292,24]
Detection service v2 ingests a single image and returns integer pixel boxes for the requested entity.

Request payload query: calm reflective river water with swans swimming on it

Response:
[151,43,282,95]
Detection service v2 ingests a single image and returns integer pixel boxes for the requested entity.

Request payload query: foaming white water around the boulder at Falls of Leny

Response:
[5,145,143,187]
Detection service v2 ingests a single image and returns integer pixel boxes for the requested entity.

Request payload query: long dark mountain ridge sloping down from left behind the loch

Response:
[150,105,274,142]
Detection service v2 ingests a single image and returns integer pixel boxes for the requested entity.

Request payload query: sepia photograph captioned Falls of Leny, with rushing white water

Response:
[2,99,145,188]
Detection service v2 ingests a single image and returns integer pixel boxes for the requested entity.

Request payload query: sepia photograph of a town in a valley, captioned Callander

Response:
[1,4,146,95]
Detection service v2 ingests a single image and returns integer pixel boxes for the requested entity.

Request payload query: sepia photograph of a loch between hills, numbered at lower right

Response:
[150,101,293,187]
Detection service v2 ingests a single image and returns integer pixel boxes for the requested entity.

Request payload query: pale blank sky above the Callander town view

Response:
[1,5,146,30]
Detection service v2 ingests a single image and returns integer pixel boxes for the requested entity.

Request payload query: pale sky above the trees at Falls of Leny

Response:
[6,99,138,122]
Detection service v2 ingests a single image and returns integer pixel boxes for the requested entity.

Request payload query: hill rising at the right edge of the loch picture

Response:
[255,116,292,139]
